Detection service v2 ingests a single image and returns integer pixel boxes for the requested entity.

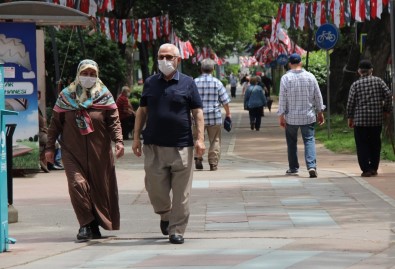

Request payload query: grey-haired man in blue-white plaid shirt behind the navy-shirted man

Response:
[195,59,231,171]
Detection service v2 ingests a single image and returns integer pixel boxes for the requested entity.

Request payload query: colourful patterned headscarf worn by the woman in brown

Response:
[54,59,117,135]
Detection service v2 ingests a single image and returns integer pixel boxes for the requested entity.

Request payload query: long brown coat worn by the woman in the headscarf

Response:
[47,109,122,230]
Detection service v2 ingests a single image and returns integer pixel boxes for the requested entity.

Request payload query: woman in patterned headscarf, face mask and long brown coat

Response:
[45,60,124,240]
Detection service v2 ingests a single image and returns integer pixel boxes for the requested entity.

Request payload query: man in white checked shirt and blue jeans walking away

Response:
[277,53,325,178]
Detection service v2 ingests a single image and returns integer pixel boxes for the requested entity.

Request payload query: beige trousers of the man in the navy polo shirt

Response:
[143,145,193,235]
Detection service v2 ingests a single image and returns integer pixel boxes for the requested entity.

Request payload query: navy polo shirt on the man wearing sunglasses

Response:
[140,71,203,147]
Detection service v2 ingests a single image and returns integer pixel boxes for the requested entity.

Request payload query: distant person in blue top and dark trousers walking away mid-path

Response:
[244,76,266,131]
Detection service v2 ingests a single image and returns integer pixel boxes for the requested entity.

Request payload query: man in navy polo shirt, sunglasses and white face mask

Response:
[132,43,205,244]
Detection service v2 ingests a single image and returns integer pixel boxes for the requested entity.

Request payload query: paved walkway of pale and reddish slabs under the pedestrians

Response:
[0,93,395,269]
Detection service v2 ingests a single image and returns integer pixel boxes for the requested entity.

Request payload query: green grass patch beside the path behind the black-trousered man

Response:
[316,115,395,161]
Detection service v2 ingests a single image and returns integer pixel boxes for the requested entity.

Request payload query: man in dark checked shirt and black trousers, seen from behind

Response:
[347,60,392,177]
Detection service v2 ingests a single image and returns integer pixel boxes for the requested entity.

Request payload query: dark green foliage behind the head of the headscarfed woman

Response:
[45,28,126,101]
